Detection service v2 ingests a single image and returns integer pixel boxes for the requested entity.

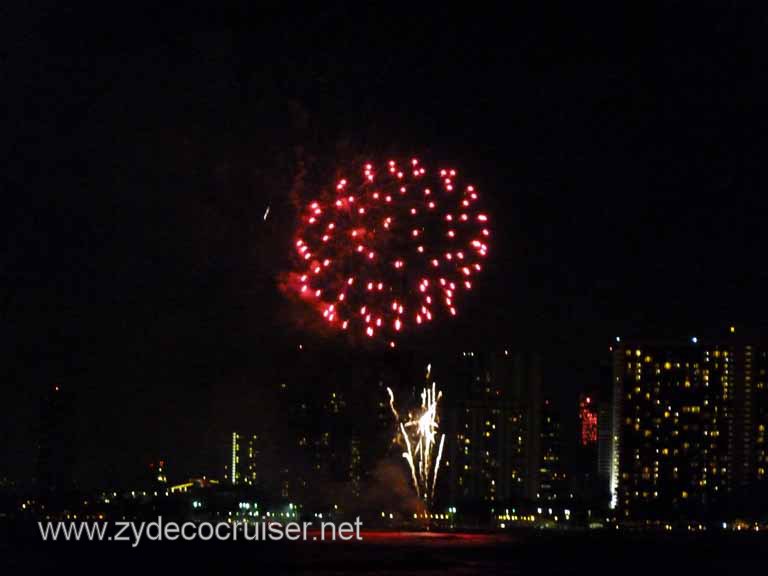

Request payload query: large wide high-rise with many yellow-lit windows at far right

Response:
[601,329,765,519]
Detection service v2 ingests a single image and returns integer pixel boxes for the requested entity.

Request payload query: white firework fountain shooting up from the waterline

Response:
[387,382,445,505]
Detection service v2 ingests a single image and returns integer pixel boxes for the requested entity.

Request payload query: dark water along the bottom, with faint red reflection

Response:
[0,525,768,576]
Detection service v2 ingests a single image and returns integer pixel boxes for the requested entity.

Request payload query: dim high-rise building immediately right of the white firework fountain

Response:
[444,351,541,504]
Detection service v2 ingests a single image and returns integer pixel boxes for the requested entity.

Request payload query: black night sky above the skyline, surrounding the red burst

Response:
[0,3,768,483]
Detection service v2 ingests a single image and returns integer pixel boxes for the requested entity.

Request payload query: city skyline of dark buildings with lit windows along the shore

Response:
[24,325,768,524]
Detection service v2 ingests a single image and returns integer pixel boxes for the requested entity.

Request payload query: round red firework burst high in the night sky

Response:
[290,158,491,347]
